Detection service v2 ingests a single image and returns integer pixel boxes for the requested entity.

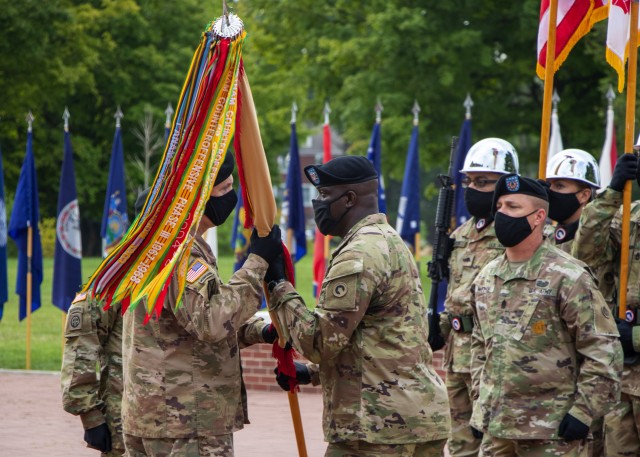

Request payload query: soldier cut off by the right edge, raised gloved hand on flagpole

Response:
[573,154,640,457]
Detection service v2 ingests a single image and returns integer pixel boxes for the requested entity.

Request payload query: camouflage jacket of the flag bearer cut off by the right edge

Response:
[572,188,640,397]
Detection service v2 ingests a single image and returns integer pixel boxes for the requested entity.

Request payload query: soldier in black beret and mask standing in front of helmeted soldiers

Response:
[471,174,622,457]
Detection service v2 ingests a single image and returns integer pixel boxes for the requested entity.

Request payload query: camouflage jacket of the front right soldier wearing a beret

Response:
[471,242,622,440]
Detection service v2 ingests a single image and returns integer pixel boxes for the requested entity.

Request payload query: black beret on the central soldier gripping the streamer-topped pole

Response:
[304,156,378,187]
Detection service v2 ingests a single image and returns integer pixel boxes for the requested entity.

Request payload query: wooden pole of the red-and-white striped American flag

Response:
[538,0,558,179]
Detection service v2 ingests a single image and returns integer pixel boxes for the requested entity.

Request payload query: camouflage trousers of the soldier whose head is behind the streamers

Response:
[124,433,233,457]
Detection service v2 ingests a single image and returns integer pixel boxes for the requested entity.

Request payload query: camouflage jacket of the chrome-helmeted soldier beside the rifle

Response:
[440,217,504,373]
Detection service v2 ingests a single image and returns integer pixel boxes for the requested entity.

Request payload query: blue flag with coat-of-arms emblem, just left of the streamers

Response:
[100,123,129,255]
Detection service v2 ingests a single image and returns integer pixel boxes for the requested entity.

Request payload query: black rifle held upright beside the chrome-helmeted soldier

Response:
[427,136,458,351]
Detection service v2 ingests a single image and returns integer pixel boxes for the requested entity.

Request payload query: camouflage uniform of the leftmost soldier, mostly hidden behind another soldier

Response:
[60,294,124,454]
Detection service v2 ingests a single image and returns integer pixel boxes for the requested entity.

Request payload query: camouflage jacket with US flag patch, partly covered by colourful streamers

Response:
[122,236,267,438]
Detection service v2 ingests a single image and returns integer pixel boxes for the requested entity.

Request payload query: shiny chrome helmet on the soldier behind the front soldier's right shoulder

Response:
[547,149,600,188]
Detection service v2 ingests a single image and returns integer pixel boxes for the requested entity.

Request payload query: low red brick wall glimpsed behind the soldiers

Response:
[240,344,444,393]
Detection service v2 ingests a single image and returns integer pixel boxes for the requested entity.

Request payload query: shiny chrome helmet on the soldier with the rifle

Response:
[460,138,518,174]
